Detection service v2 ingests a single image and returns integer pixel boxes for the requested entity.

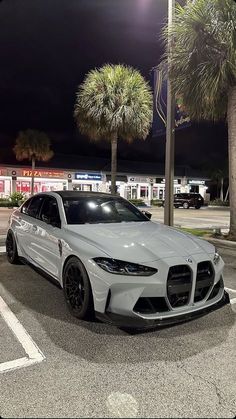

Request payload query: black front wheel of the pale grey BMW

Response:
[63,257,94,319]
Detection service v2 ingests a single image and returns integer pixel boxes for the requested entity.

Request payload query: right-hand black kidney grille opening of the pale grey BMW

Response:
[194,261,214,303]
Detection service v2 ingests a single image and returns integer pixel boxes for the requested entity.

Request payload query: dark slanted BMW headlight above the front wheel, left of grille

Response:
[93,258,158,276]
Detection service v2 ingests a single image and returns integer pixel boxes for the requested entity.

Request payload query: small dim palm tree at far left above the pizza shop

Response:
[13,129,53,195]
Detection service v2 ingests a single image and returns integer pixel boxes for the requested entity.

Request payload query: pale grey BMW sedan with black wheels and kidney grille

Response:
[6,191,229,328]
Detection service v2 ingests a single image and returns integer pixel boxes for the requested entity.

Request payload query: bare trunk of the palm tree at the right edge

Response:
[227,86,236,240]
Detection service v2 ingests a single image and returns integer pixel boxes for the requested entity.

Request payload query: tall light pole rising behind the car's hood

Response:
[164,0,175,226]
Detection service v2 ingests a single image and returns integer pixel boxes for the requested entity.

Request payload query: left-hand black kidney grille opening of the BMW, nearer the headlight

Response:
[167,265,192,308]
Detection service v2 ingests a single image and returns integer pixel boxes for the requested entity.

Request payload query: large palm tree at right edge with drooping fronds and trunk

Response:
[164,0,236,240]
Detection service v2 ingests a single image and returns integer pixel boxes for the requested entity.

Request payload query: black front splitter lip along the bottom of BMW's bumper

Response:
[96,290,230,329]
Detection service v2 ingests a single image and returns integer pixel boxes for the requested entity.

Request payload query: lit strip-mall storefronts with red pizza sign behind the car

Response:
[0,166,209,204]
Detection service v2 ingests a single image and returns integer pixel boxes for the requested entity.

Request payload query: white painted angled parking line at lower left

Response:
[0,297,45,372]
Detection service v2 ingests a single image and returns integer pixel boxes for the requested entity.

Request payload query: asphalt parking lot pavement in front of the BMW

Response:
[0,244,236,418]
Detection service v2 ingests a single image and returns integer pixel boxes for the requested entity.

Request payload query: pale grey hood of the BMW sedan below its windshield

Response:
[66,221,214,262]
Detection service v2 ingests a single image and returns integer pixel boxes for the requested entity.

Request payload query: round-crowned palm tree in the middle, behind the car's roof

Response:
[74,64,152,193]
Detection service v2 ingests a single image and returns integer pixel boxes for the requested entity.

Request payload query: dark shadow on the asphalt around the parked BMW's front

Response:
[0,257,236,364]
